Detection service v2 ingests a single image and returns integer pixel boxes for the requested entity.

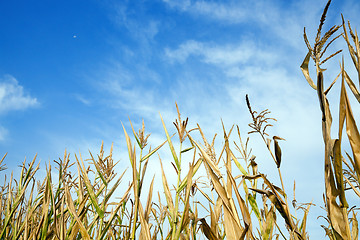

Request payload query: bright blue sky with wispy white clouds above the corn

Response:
[0,0,360,239]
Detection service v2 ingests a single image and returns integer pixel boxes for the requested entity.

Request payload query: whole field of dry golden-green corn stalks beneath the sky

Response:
[0,0,360,240]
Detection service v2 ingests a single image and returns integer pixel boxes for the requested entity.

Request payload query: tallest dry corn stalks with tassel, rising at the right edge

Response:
[301,0,360,239]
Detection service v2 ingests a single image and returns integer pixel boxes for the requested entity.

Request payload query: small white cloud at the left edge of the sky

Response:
[0,75,39,113]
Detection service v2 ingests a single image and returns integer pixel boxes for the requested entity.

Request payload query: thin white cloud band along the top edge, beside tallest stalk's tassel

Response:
[163,0,332,50]
